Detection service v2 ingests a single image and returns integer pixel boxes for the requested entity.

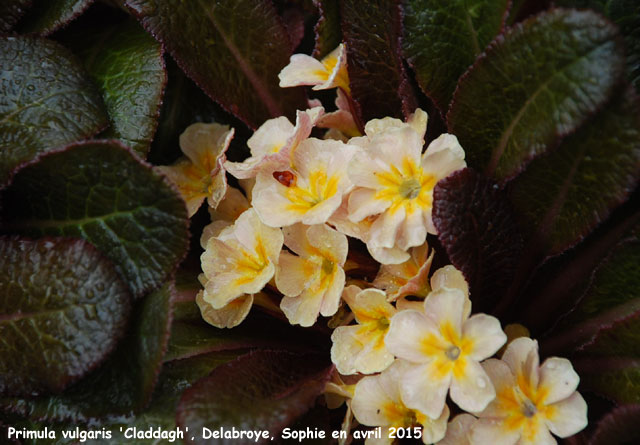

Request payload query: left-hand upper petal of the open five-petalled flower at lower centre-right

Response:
[384,310,440,362]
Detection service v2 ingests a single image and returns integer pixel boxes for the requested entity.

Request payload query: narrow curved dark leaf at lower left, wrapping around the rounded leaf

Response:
[0,284,174,423]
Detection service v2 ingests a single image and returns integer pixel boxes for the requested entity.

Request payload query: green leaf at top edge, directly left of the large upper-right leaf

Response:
[403,0,509,114]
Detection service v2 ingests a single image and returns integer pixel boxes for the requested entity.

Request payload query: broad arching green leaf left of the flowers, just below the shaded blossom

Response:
[4,141,188,296]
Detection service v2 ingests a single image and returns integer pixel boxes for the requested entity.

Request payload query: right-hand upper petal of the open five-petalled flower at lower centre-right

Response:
[462,314,507,361]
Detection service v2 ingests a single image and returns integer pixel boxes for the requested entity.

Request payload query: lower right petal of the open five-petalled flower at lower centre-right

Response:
[450,360,496,412]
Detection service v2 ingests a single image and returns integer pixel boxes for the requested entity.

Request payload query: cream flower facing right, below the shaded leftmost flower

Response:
[201,209,283,309]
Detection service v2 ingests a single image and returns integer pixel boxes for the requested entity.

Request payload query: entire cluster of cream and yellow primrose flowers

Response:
[160,45,587,444]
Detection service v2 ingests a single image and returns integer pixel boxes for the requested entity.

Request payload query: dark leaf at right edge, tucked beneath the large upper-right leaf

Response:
[512,89,640,255]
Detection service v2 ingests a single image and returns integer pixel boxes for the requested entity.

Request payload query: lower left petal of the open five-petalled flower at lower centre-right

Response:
[400,360,451,419]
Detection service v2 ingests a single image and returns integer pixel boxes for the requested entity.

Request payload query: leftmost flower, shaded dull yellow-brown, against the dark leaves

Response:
[157,123,234,217]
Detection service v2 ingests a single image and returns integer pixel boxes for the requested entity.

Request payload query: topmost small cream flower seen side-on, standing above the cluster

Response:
[278,43,350,94]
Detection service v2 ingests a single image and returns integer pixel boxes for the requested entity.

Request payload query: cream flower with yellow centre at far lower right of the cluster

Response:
[470,337,587,445]
